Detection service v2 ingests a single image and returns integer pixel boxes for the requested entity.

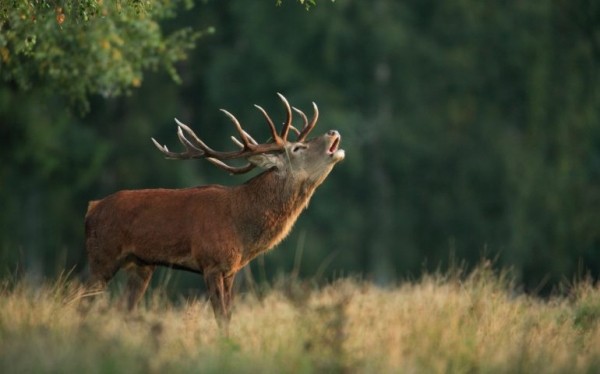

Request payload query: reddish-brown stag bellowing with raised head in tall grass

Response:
[85,93,345,334]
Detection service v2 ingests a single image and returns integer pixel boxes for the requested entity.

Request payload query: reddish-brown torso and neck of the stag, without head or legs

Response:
[86,171,314,281]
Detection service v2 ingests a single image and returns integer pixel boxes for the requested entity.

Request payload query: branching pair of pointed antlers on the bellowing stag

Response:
[152,93,318,174]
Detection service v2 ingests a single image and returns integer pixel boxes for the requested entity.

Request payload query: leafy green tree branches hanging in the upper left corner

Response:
[0,0,200,110]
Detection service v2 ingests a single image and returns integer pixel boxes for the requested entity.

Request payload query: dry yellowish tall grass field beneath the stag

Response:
[0,266,600,373]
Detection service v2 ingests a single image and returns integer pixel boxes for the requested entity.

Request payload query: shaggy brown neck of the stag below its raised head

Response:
[238,169,316,261]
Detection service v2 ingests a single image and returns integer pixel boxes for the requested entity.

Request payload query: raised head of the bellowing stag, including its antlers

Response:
[152,93,345,185]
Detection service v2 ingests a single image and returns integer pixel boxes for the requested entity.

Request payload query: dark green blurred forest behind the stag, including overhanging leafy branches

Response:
[0,0,600,292]
